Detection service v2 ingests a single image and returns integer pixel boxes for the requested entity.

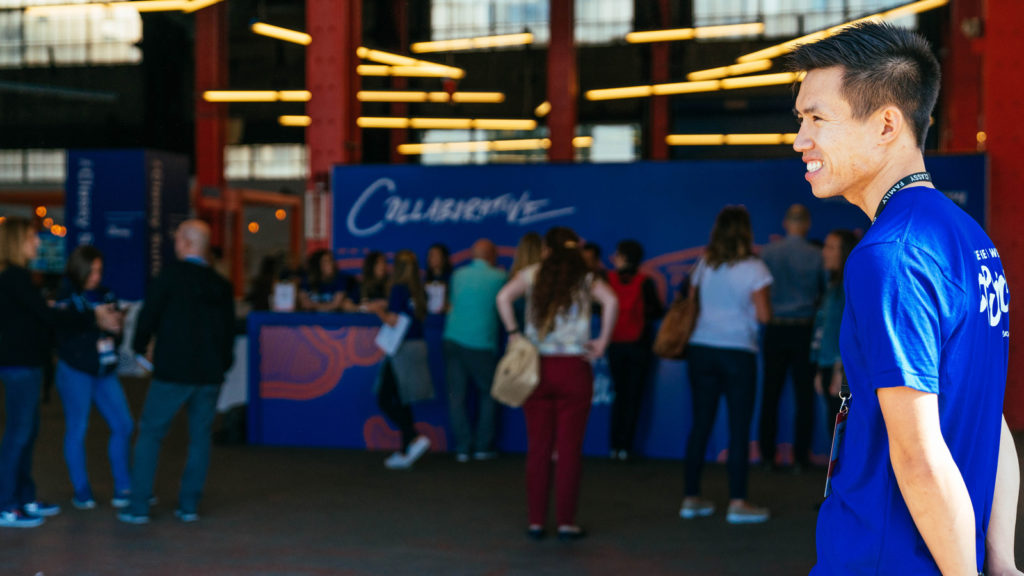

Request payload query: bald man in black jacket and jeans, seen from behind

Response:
[118,220,234,524]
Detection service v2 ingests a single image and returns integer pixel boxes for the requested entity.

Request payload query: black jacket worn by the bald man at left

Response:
[132,261,234,384]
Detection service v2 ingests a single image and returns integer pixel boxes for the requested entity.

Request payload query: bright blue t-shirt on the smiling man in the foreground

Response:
[812,188,1010,576]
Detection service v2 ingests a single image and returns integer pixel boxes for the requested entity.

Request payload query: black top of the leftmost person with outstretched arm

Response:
[0,265,96,367]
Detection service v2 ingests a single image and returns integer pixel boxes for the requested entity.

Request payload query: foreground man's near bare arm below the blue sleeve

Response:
[877,386,978,576]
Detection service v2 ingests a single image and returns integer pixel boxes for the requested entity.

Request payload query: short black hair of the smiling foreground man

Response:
[788,23,941,149]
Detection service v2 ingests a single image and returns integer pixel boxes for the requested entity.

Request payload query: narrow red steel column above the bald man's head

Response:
[195,2,228,241]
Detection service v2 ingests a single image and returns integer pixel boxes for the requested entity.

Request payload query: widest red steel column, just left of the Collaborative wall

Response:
[306,0,362,250]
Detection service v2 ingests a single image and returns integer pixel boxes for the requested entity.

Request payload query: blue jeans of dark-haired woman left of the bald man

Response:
[56,361,135,501]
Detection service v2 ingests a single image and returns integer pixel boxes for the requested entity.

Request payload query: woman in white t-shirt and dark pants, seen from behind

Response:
[679,206,772,524]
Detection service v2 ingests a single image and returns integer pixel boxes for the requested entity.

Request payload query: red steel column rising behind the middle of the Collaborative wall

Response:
[548,0,580,162]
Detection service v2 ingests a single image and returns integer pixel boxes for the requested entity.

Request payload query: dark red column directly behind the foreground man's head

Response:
[939,0,982,153]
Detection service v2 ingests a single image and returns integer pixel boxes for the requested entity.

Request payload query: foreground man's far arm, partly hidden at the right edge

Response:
[985,417,1024,576]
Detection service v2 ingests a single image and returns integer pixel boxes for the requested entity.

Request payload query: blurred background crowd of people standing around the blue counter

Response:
[0,205,872,538]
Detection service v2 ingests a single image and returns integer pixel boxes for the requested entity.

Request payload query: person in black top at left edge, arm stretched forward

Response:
[0,216,121,528]
